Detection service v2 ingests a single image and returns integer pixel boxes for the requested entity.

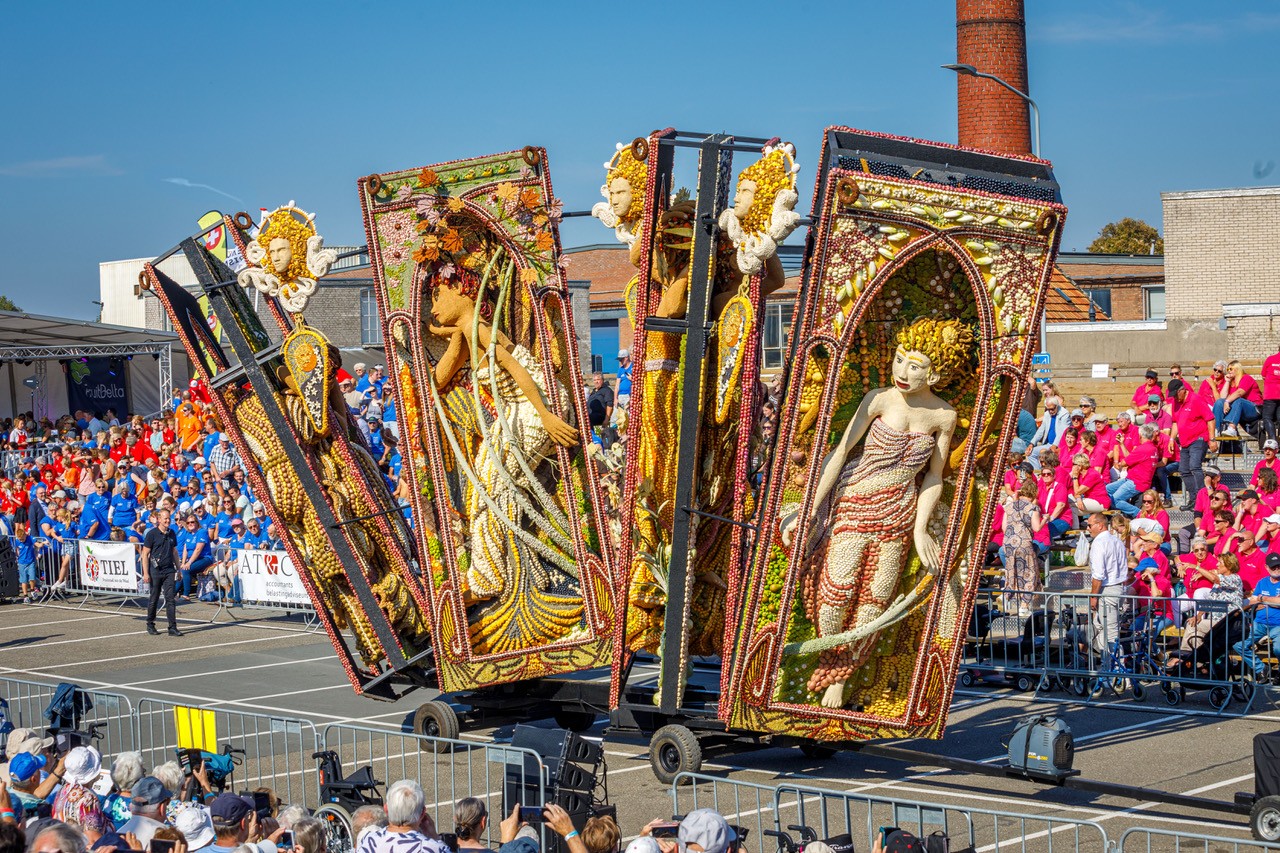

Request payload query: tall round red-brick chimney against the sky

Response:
[956,0,1032,154]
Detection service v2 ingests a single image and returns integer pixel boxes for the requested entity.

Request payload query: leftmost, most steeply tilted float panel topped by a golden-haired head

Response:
[141,202,434,698]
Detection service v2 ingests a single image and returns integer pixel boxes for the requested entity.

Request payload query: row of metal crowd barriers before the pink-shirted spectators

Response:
[960,590,1270,713]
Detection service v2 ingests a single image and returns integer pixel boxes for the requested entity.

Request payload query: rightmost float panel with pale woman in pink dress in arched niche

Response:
[721,127,1066,742]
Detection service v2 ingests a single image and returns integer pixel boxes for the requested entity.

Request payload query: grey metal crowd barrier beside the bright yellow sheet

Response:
[134,699,320,808]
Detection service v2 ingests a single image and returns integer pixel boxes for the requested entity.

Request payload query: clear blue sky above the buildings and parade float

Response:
[0,0,1280,319]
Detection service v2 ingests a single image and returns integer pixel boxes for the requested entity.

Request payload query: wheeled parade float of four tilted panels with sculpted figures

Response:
[143,127,1065,780]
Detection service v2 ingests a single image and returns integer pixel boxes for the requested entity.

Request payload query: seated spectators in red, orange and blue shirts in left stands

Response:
[0,364,408,605]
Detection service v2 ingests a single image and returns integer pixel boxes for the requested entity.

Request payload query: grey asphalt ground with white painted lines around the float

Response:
[0,603,1280,853]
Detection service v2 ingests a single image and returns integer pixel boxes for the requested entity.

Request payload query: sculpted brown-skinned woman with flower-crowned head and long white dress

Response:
[426,218,581,652]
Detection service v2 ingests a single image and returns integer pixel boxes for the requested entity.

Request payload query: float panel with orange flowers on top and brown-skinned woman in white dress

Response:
[360,147,617,690]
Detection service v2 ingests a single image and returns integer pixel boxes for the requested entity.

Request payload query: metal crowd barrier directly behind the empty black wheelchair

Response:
[320,724,548,843]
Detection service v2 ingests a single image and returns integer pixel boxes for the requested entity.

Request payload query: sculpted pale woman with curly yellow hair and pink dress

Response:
[782,319,973,708]
